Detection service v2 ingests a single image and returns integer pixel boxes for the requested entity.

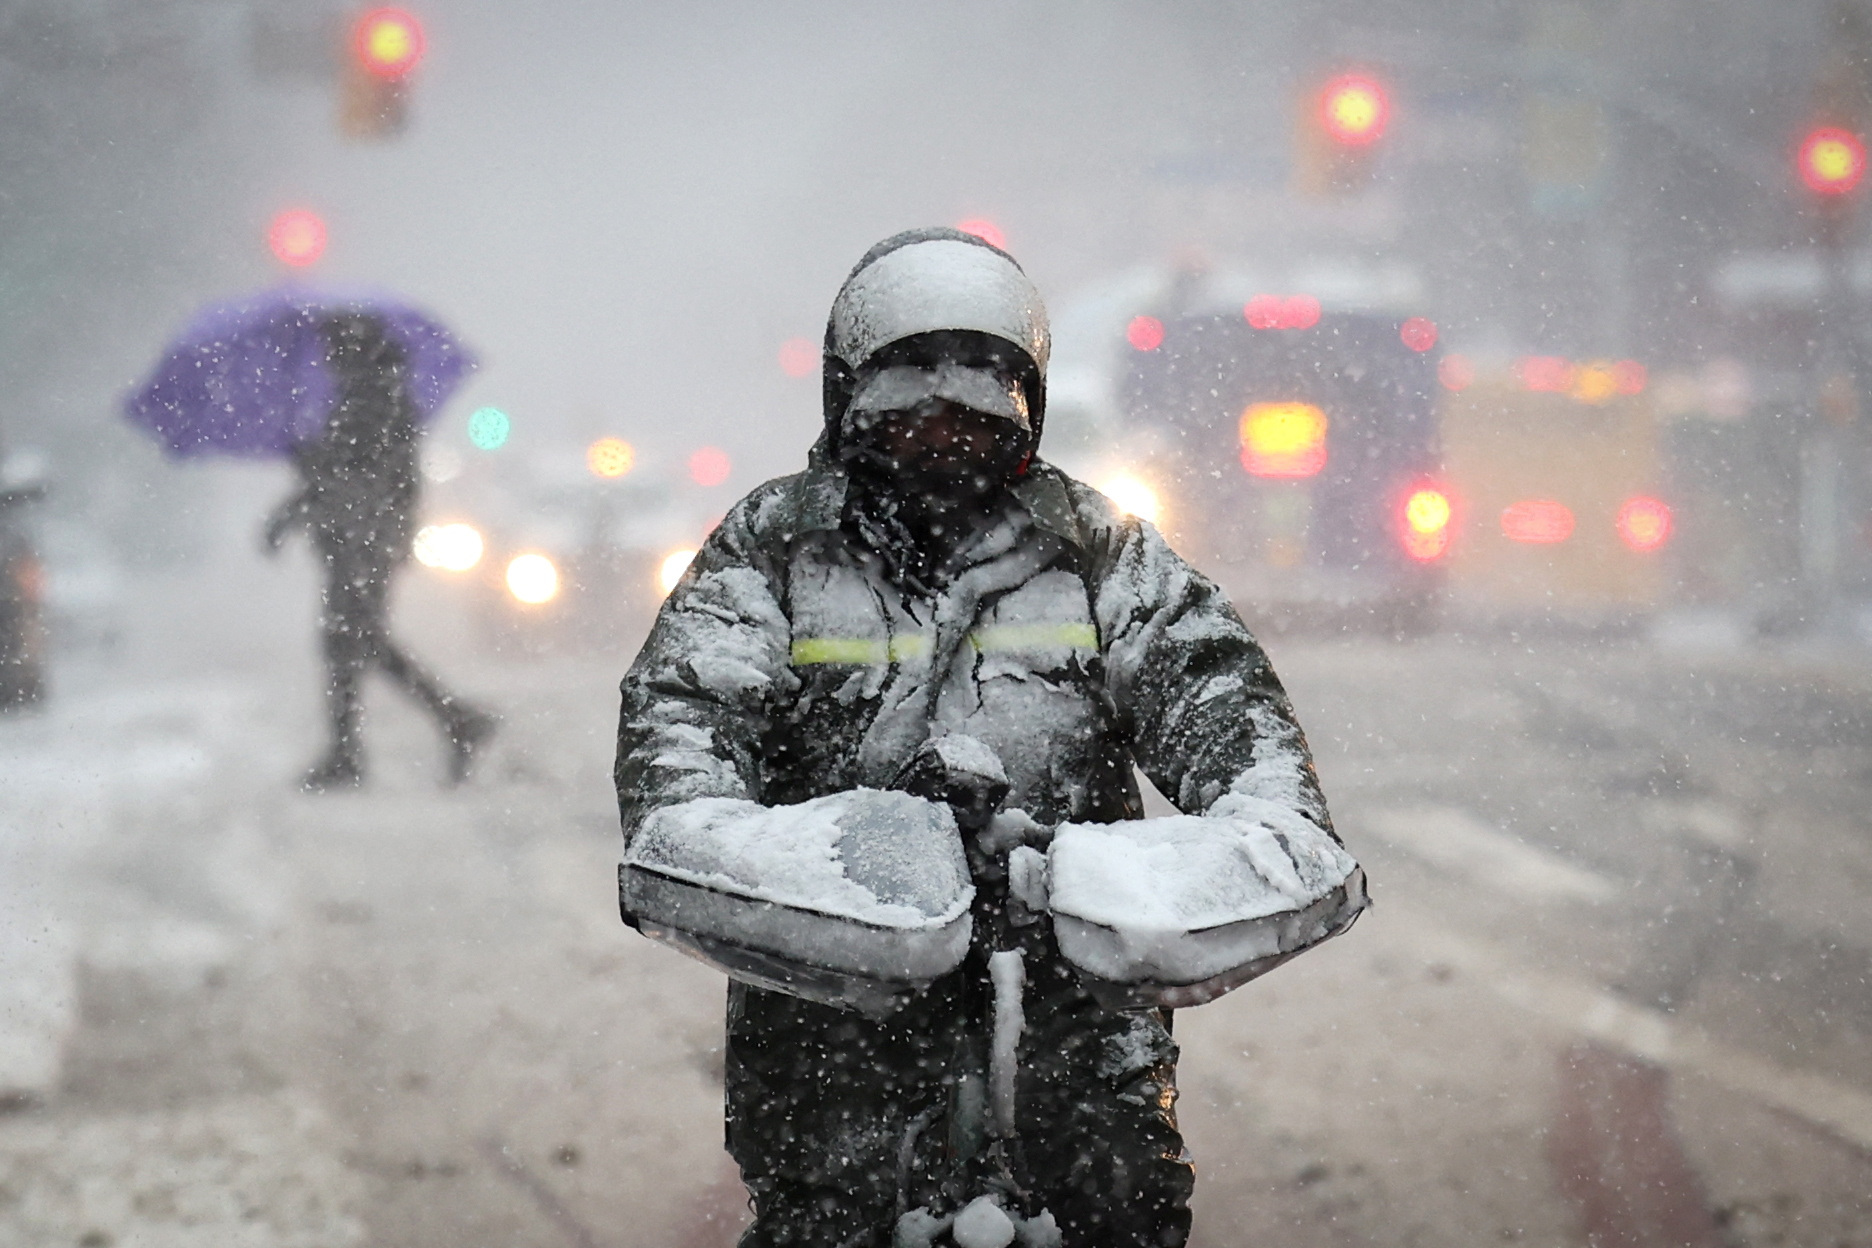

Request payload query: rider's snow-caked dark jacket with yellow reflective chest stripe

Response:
[616,455,1331,860]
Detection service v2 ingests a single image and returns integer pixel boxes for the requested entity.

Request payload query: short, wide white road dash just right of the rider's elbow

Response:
[1365,806,1619,906]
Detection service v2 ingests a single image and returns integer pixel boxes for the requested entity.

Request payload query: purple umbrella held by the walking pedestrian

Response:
[124,288,475,457]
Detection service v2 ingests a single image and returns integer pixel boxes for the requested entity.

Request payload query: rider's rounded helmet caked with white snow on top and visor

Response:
[826,228,1052,434]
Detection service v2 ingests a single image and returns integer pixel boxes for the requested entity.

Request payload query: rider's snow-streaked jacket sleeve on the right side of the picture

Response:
[1082,493,1338,840]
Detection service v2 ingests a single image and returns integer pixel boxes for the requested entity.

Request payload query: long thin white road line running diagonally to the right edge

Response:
[1370,902,1872,1151]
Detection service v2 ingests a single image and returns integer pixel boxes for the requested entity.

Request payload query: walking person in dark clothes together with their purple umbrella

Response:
[127,292,496,791]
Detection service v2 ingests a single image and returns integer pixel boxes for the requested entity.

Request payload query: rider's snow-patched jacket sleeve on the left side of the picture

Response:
[614,496,794,846]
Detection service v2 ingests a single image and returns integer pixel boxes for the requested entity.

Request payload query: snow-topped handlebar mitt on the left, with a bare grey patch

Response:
[618,790,975,1012]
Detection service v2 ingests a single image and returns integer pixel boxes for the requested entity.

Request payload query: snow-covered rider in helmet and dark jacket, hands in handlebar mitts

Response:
[616,228,1363,1248]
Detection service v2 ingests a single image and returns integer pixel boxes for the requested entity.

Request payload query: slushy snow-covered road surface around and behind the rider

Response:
[0,580,1872,1248]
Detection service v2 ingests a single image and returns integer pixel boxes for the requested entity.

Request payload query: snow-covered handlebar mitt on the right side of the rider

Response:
[1046,793,1368,1007]
